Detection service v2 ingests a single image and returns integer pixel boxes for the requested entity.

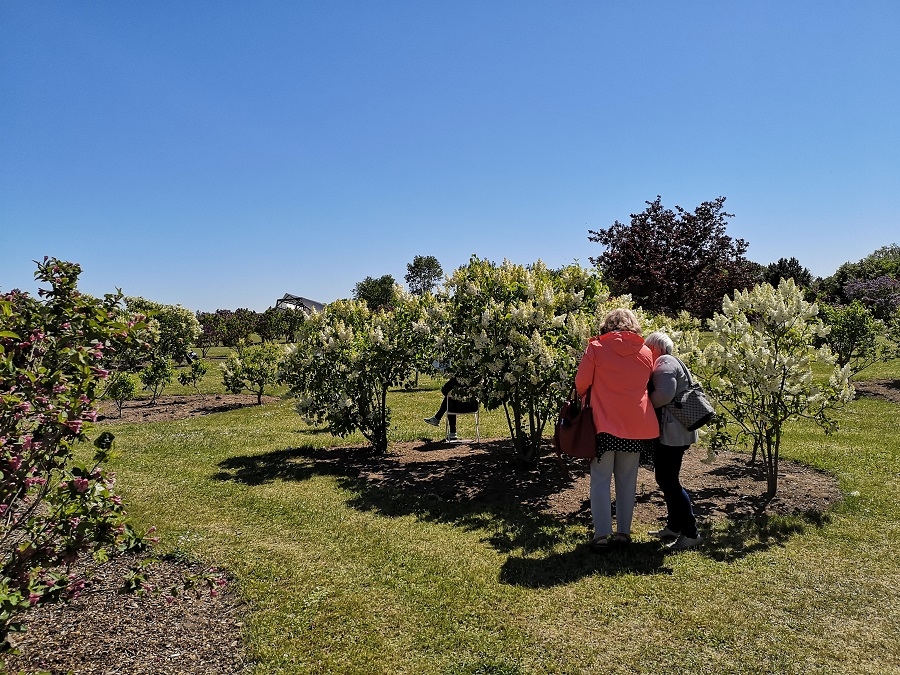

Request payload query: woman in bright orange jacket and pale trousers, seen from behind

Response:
[575,309,659,551]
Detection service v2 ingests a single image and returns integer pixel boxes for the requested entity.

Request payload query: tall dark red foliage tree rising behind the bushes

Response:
[588,196,754,317]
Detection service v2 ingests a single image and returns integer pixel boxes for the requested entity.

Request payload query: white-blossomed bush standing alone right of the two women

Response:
[697,279,853,496]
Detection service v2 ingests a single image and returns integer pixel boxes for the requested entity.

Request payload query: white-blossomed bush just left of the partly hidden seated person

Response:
[281,289,434,452]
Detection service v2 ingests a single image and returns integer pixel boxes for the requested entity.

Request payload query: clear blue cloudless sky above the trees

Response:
[0,0,900,310]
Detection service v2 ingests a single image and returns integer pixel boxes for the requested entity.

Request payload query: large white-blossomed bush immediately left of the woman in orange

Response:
[436,256,621,462]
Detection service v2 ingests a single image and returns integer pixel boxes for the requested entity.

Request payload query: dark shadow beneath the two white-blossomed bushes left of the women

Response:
[212,441,575,553]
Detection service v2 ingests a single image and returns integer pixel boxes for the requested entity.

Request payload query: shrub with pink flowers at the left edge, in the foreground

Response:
[0,258,152,650]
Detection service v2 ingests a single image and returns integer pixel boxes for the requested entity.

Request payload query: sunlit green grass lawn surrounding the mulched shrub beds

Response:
[100,362,900,675]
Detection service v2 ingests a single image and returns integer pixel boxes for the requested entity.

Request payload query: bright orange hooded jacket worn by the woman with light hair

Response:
[575,331,659,439]
